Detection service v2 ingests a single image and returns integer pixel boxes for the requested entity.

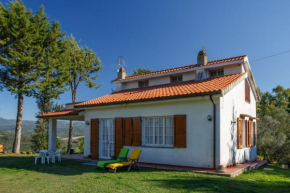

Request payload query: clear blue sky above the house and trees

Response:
[0,0,290,120]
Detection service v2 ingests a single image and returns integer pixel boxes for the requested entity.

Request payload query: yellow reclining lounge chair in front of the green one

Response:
[106,149,141,173]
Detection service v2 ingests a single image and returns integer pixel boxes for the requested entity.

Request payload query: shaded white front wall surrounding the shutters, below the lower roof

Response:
[84,96,213,168]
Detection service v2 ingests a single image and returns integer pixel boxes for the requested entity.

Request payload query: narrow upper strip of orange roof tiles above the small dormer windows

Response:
[112,55,247,82]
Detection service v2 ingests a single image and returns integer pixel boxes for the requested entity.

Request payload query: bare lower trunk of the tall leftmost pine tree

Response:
[12,93,23,154]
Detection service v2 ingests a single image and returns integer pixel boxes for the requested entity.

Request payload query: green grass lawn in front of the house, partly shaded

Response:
[0,155,290,193]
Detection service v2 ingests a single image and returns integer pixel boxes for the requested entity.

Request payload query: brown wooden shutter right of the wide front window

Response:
[174,115,186,148]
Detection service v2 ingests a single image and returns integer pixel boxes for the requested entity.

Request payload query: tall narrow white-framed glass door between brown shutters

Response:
[100,119,115,158]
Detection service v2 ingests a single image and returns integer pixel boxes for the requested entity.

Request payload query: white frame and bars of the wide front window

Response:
[141,115,174,148]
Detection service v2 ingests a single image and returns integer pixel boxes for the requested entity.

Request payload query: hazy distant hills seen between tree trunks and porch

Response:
[0,117,85,138]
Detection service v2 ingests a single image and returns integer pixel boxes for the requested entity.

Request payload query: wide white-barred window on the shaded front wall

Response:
[143,117,173,147]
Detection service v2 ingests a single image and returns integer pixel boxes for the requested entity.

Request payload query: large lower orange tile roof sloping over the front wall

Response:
[75,73,245,108]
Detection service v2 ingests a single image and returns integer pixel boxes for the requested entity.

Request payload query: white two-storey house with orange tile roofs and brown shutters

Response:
[38,51,260,168]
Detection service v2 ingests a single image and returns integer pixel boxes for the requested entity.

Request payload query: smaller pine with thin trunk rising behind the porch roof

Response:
[65,36,103,154]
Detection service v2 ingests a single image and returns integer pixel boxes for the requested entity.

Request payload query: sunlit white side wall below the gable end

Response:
[219,78,257,165]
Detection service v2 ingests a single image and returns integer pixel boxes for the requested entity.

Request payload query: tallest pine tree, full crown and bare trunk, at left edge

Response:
[0,1,67,153]
